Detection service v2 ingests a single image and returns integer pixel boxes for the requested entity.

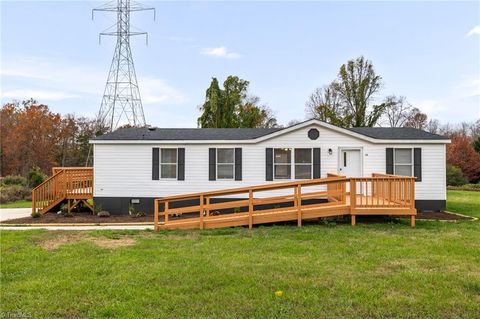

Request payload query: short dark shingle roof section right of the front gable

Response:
[348,127,448,140]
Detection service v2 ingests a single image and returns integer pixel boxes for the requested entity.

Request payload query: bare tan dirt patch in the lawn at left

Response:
[38,232,136,251]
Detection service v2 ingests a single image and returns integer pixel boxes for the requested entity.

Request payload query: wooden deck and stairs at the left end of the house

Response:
[32,167,93,214]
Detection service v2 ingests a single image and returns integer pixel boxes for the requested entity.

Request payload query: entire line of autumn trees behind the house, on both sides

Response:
[0,57,480,182]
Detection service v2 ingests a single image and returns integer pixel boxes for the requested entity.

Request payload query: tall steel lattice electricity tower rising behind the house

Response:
[92,0,155,131]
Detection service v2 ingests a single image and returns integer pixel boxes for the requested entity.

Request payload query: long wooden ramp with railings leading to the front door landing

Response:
[155,174,416,230]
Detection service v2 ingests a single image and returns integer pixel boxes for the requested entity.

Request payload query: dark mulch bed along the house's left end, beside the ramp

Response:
[1,212,156,224]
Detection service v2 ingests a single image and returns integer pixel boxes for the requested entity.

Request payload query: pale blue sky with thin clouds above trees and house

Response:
[0,0,480,127]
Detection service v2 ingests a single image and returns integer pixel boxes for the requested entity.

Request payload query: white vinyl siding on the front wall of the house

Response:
[94,125,446,200]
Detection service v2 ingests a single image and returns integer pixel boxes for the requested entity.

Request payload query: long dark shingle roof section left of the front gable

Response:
[94,127,281,141]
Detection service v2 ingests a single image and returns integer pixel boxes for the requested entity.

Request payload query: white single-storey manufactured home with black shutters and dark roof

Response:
[91,120,449,213]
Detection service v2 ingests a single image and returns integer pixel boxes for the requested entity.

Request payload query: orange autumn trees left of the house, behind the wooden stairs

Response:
[0,99,107,176]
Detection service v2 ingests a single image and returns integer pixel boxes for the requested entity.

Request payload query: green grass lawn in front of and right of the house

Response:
[0,191,480,318]
